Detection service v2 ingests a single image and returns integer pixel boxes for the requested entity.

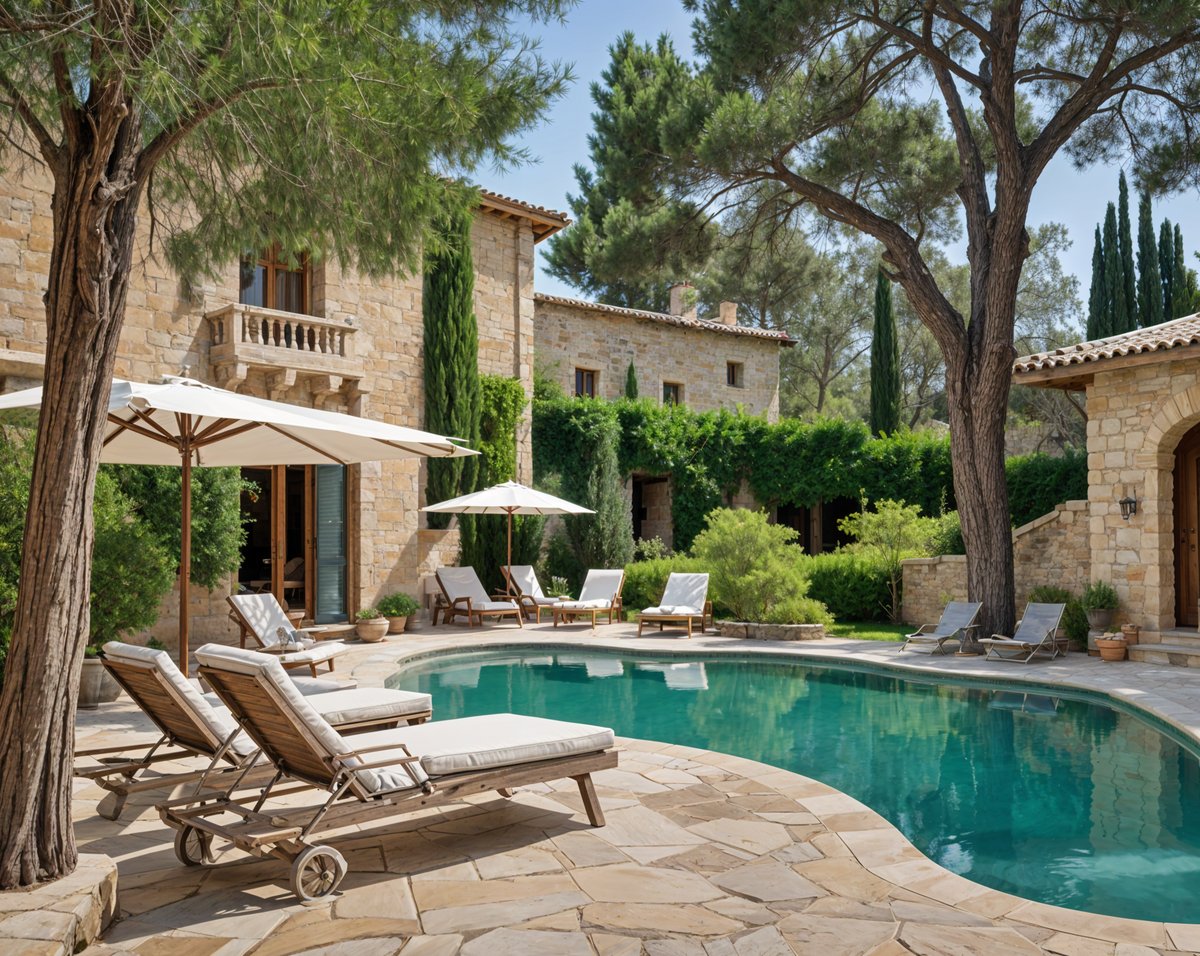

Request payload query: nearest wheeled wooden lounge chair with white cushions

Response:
[158,644,617,901]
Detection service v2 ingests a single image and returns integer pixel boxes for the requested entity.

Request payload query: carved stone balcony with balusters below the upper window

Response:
[204,305,362,398]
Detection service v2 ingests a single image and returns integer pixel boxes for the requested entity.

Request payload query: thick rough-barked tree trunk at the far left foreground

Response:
[0,112,140,890]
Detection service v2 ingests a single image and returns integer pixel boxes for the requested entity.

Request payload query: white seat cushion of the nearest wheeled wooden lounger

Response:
[353,714,614,776]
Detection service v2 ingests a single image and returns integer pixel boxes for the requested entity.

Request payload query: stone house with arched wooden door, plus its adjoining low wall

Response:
[905,315,1200,667]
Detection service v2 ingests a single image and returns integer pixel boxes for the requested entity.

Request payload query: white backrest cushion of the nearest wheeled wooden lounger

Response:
[196,644,425,793]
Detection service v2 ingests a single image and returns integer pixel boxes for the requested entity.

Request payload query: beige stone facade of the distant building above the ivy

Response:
[534,294,790,421]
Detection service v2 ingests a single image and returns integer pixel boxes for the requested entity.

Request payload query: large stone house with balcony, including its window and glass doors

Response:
[0,154,568,642]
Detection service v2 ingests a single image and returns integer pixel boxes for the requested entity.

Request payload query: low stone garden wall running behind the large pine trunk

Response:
[901,501,1092,625]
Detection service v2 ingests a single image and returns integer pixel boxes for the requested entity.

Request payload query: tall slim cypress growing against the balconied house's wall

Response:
[421,212,480,536]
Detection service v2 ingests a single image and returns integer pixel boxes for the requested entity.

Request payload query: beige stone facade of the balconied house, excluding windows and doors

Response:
[0,158,566,639]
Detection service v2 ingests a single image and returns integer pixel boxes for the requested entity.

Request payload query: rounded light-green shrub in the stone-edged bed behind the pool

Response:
[691,509,829,624]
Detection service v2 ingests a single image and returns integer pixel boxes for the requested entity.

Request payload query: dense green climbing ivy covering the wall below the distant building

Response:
[533,398,1087,549]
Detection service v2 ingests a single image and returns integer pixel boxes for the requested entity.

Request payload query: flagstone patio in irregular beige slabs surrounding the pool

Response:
[49,625,1200,956]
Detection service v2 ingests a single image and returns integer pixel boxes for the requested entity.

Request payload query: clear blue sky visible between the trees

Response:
[480,0,1200,316]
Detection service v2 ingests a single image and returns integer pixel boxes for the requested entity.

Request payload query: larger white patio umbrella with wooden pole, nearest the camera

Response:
[0,378,478,674]
